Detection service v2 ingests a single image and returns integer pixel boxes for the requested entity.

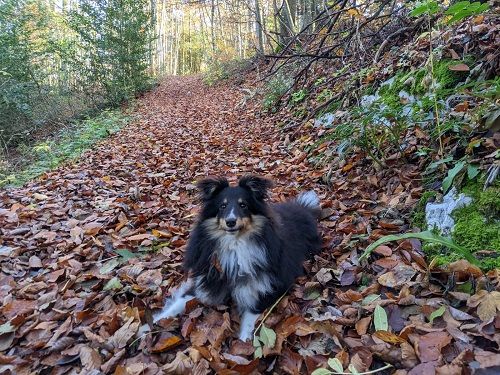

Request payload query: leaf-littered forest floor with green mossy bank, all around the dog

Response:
[0,2,500,375]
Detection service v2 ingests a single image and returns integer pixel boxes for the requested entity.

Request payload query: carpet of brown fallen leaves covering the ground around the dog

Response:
[0,77,500,375]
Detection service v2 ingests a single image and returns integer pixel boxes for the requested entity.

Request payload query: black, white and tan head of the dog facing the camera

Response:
[198,175,272,234]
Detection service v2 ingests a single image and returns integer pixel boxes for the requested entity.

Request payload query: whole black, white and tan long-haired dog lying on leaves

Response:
[155,176,321,340]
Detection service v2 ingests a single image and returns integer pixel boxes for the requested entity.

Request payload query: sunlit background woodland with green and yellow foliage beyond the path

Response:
[0,0,332,150]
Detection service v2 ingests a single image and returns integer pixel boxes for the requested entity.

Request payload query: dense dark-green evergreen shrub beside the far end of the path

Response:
[69,0,153,105]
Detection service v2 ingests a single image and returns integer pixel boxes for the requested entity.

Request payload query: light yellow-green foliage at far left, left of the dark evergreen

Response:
[0,0,78,146]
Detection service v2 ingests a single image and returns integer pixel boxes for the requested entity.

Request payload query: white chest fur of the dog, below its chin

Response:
[217,234,272,309]
